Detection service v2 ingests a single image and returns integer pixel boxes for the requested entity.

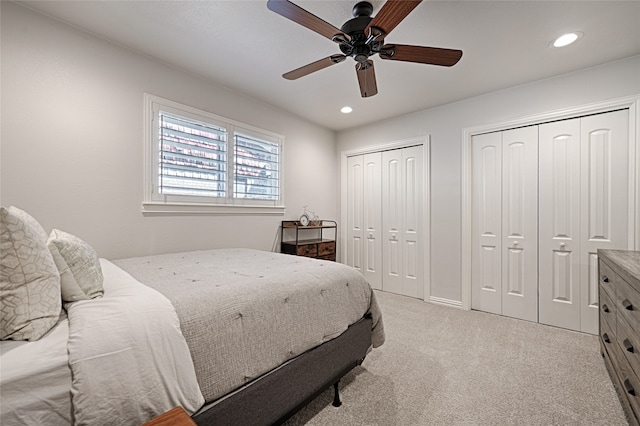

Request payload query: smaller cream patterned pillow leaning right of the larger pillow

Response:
[47,229,104,302]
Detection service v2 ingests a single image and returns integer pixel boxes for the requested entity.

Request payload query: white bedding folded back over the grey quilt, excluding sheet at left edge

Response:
[68,259,204,425]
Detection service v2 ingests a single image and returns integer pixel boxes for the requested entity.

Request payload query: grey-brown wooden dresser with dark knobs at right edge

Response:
[598,250,640,425]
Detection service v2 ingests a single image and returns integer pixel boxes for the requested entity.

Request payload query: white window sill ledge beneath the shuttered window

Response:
[142,202,285,216]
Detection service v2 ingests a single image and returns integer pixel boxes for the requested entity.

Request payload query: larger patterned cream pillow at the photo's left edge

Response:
[0,206,62,340]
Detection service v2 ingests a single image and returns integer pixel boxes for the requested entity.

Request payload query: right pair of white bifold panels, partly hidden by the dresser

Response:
[539,110,630,334]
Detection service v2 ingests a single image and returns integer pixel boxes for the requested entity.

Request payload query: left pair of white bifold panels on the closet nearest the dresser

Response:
[471,127,538,321]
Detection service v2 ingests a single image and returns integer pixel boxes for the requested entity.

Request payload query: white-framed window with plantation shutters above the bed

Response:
[143,95,284,214]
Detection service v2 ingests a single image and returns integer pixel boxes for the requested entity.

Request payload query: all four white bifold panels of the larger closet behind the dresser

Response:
[471,110,632,334]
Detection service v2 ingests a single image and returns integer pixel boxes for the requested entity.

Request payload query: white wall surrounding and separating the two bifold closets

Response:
[338,56,640,301]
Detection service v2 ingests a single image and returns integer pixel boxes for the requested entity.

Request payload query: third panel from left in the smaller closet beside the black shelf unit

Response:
[382,150,403,294]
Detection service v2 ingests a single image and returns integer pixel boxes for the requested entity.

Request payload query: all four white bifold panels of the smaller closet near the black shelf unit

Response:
[346,145,424,299]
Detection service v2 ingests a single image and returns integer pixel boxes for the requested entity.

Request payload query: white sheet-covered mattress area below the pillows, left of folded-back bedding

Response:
[0,314,71,426]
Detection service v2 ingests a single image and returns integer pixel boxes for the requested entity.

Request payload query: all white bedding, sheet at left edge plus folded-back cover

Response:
[0,259,204,426]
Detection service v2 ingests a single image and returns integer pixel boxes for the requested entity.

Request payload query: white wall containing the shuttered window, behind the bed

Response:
[0,1,339,258]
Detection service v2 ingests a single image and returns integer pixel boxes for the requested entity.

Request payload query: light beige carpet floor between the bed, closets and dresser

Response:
[286,292,627,426]
